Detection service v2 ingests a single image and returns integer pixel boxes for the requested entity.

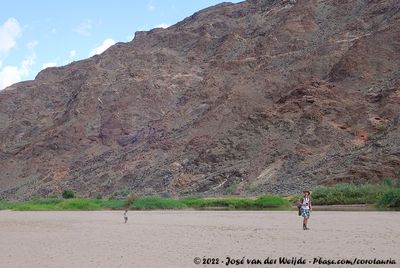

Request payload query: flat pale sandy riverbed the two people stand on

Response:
[0,211,400,268]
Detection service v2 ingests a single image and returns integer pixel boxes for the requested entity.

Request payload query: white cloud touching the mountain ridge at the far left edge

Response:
[0,41,38,90]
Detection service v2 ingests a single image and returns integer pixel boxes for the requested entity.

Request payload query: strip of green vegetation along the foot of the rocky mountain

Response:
[0,179,400,211]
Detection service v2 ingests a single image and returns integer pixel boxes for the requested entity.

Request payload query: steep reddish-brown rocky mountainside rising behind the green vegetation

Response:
[0,0,400,199]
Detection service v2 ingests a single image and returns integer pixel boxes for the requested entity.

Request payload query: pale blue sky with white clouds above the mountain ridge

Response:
[0,0,240,90]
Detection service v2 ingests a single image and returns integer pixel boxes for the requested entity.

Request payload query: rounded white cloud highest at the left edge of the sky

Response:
[0,18,21,57]
